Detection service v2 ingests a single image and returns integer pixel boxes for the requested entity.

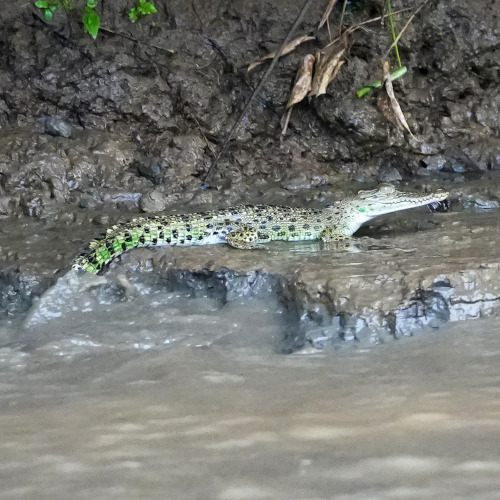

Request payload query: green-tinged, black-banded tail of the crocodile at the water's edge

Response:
[72,221,164,274]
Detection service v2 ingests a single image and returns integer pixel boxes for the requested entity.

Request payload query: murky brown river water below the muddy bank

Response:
[0,276,500,500]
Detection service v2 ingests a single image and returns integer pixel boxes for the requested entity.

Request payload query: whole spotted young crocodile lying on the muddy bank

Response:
[73,184,448,274]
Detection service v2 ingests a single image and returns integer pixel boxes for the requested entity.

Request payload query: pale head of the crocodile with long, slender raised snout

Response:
[351,184,448,218]
